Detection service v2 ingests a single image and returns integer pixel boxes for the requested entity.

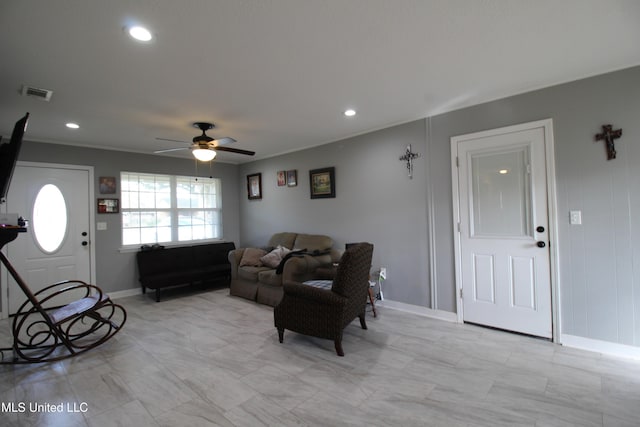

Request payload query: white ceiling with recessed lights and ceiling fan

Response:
[0,0,640,163]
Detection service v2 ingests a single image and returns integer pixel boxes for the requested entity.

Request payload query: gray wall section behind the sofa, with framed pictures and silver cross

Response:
[239,120,430,306]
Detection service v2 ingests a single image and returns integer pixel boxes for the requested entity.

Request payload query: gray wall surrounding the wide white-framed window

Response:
[19,141,240,292]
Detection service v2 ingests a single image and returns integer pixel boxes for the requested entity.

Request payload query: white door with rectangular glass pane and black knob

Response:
[451,121,552,338]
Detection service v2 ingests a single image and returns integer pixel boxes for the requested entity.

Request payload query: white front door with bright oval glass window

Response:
[3,163,94,314]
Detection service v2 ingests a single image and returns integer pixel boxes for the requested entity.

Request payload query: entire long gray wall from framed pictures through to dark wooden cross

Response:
[238,67,640,346]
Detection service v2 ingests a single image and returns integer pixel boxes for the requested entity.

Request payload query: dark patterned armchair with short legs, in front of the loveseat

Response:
[273,243,373,356]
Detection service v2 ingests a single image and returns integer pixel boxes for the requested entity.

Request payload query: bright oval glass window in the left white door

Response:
[32,184,67,253]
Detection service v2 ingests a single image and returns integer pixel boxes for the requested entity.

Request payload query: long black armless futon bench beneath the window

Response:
[137,242,235,301]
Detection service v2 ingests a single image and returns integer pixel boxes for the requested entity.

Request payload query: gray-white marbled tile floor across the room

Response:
[0,289,640,427]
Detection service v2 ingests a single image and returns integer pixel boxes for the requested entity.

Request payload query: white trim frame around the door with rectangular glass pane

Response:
[450,118,562,342]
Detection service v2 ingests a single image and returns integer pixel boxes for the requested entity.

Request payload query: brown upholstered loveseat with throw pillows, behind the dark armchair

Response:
[229,233,342,307]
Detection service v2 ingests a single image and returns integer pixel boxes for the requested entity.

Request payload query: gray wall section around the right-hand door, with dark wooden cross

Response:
[431,67,640,346]
